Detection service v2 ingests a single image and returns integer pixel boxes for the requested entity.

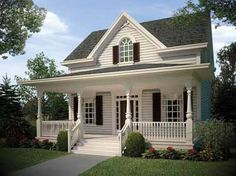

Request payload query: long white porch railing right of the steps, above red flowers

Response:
[132,122,186,142]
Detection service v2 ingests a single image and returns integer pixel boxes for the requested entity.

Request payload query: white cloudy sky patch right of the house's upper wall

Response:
[212,24,236,74]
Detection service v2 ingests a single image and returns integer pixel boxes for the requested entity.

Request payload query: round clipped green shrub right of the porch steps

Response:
[125,132,145,157]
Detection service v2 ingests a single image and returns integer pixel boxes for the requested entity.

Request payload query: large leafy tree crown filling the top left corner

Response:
[0,0,46,59]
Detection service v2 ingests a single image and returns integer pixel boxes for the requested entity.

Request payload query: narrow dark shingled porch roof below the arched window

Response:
[59,64,186,77]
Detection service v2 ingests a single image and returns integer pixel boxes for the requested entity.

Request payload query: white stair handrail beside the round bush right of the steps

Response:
[118,123,130,156]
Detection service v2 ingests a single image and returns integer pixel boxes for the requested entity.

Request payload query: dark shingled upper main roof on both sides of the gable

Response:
[65,13,209,61]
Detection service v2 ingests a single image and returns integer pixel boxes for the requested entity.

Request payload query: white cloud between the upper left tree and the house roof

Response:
[0,11,81,82]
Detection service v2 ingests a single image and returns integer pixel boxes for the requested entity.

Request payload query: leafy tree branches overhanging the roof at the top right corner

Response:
[173,0,236,26]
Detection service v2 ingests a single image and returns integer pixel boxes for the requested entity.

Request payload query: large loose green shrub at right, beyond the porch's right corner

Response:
[196,119,234,155]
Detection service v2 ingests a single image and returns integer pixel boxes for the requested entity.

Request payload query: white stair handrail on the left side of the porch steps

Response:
[67,121,81,152]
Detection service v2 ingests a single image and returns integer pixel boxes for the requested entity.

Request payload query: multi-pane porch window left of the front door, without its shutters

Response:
[83,99,96,124]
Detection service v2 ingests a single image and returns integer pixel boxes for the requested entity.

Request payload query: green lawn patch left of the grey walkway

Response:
[0,148,67,175]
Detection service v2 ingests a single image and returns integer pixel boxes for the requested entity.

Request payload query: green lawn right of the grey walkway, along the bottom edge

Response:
[81,157,236,176]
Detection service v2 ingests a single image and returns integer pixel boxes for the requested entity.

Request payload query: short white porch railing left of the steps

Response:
[41,120,74,137]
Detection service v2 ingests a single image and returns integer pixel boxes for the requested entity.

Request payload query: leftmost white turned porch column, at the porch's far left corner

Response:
[36,90,43,137]
